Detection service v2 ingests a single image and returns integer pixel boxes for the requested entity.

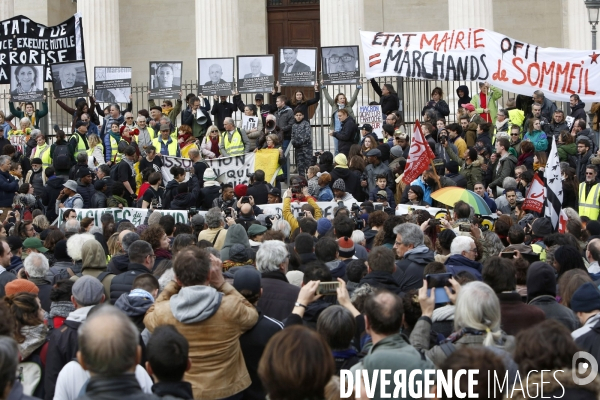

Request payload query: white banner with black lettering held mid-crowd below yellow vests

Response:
[161,153,254,187]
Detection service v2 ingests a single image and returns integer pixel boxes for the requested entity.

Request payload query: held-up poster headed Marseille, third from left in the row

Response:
[94,67,131,103]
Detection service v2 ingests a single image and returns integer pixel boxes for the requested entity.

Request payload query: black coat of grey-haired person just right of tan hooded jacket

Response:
[258,271,300,321]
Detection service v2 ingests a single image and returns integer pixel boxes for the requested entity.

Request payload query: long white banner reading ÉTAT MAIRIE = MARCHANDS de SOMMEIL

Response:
[360,28,600,102]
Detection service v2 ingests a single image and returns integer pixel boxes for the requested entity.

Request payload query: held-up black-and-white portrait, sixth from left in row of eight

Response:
[237,55,275,93]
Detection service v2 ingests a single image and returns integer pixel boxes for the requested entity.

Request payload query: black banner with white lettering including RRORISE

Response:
[0,15,85,84]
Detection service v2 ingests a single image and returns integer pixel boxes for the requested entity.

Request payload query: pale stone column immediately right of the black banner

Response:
[77,0,121,86]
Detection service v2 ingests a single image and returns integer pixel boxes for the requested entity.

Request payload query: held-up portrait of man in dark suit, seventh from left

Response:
[279,48,317,86]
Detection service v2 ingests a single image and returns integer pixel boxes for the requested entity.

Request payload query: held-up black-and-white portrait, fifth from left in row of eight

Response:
[198,57,233,96]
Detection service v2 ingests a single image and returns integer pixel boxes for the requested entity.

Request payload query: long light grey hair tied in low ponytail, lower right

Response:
[454,282,502,346]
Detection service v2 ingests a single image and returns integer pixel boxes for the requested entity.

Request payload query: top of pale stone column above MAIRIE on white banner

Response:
[448,0,494,30]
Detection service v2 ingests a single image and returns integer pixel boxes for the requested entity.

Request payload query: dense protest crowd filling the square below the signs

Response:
[0,64,600,400]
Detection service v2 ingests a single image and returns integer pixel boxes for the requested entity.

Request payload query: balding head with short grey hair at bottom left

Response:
[77,305,139,377]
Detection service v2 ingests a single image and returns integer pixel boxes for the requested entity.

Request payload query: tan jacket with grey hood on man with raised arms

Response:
[144,282,258,399]
